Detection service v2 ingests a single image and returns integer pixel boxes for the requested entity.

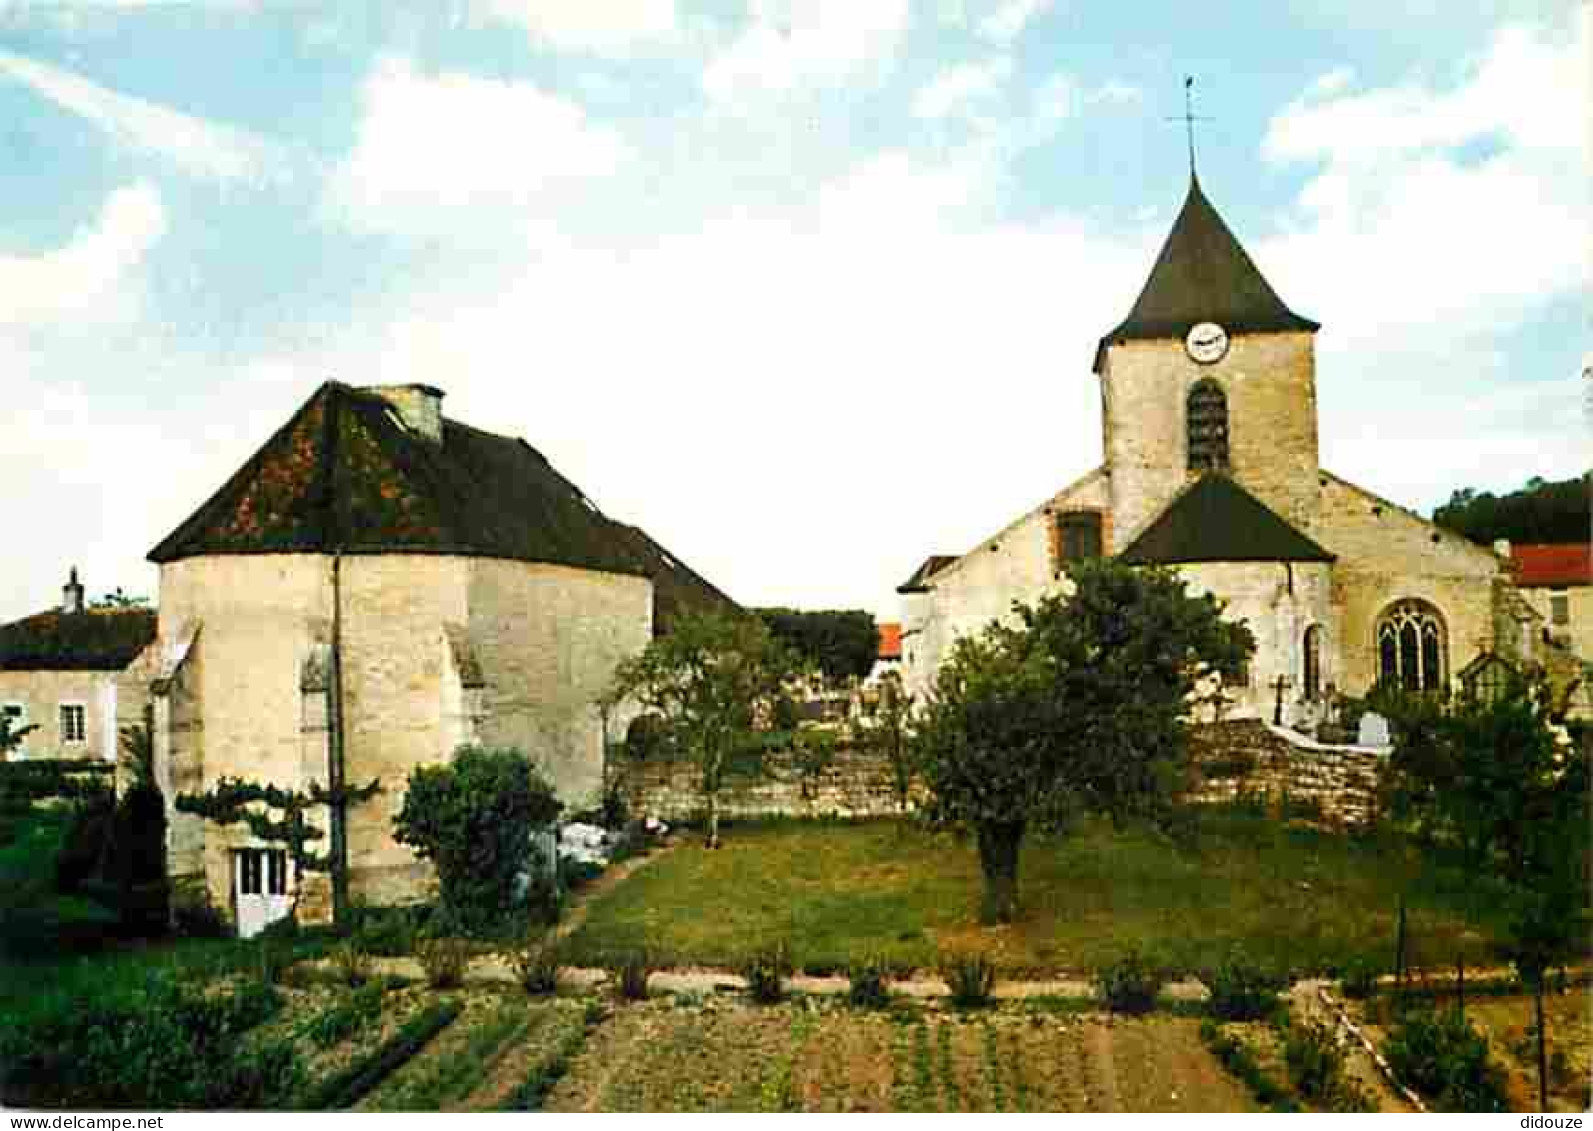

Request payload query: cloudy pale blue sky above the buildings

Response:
[0,0,1593,620]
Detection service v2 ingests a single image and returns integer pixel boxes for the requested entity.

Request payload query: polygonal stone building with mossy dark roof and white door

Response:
[148,381,738,935]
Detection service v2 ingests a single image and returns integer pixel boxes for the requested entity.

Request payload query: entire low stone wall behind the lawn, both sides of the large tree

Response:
[618,718,1388,825]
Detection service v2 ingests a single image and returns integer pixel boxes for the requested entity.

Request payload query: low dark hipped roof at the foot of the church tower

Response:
[1118,473,1333,566]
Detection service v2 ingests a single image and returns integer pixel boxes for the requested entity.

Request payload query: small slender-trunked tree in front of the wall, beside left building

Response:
[602,613,792,847]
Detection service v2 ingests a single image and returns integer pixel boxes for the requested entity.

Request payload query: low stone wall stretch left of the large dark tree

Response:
[618,747,922,820]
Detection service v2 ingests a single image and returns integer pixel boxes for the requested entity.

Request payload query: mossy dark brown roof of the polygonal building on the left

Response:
[150,381,736,629]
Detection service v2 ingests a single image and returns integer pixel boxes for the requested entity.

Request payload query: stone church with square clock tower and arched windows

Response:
[897,172,1542,728]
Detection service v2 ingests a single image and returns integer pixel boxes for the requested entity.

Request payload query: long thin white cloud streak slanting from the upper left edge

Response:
[0,51,293,183]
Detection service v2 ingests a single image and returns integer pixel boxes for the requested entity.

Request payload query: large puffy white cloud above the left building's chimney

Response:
[328,59,629,234]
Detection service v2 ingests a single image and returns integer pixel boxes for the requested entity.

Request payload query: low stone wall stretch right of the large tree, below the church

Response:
[1187,718,1389,825]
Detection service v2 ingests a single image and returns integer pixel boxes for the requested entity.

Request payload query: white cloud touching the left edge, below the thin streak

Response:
[0,183,166,327]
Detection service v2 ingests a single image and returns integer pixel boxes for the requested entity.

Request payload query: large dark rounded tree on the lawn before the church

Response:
[914,561,1255,922]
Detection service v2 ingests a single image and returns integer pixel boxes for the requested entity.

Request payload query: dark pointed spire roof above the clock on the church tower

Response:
[1096,175,1321,373]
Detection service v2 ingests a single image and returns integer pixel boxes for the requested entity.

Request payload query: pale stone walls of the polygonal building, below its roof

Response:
[159,554,652,908]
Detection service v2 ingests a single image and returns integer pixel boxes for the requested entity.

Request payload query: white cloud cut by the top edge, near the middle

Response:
[703,0,911,102]
